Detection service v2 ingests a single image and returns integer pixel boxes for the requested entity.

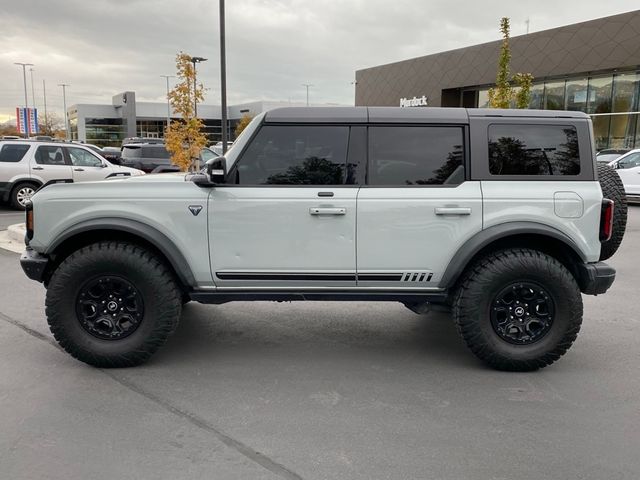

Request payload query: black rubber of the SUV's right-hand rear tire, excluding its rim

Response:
[453,249,582,371]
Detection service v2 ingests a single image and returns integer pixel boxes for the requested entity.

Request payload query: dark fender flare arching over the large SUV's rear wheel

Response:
[440,222,586,288]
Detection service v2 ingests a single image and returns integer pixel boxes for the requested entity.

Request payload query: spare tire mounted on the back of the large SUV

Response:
[598,164,627,260]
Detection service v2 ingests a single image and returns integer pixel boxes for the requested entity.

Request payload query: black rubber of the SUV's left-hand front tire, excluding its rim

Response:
[46,241,182,368]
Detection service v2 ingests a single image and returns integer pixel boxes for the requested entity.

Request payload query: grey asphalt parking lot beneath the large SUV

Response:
[0,207,640,480]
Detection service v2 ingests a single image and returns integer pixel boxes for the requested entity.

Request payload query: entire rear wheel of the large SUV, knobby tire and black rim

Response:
[453,249,582,371]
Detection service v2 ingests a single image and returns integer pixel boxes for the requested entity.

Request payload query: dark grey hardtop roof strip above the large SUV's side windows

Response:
[264,107,589,124]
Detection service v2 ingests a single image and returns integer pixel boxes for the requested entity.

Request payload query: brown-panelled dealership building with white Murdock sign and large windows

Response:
[355,10,640,149]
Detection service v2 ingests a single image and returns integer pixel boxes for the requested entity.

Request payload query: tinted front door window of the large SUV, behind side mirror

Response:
[236,125,349,185]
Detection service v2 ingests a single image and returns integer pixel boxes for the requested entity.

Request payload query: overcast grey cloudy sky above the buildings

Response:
[0,0,639,122]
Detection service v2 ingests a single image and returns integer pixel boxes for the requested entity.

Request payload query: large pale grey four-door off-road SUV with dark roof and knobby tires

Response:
[21,107,626,370]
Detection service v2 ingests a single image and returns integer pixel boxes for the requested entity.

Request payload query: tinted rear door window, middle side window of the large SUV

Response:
[368,126,464,185]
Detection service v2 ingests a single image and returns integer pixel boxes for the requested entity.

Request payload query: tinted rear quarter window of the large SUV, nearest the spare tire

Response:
[489,125,580,175]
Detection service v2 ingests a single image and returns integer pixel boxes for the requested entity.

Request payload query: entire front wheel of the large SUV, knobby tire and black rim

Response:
[46,242,182,367]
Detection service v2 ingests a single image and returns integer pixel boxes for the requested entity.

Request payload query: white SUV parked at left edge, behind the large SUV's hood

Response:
[0,140,142,210]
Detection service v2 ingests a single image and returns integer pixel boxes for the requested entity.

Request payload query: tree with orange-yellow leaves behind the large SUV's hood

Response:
[165,52,207,172]
